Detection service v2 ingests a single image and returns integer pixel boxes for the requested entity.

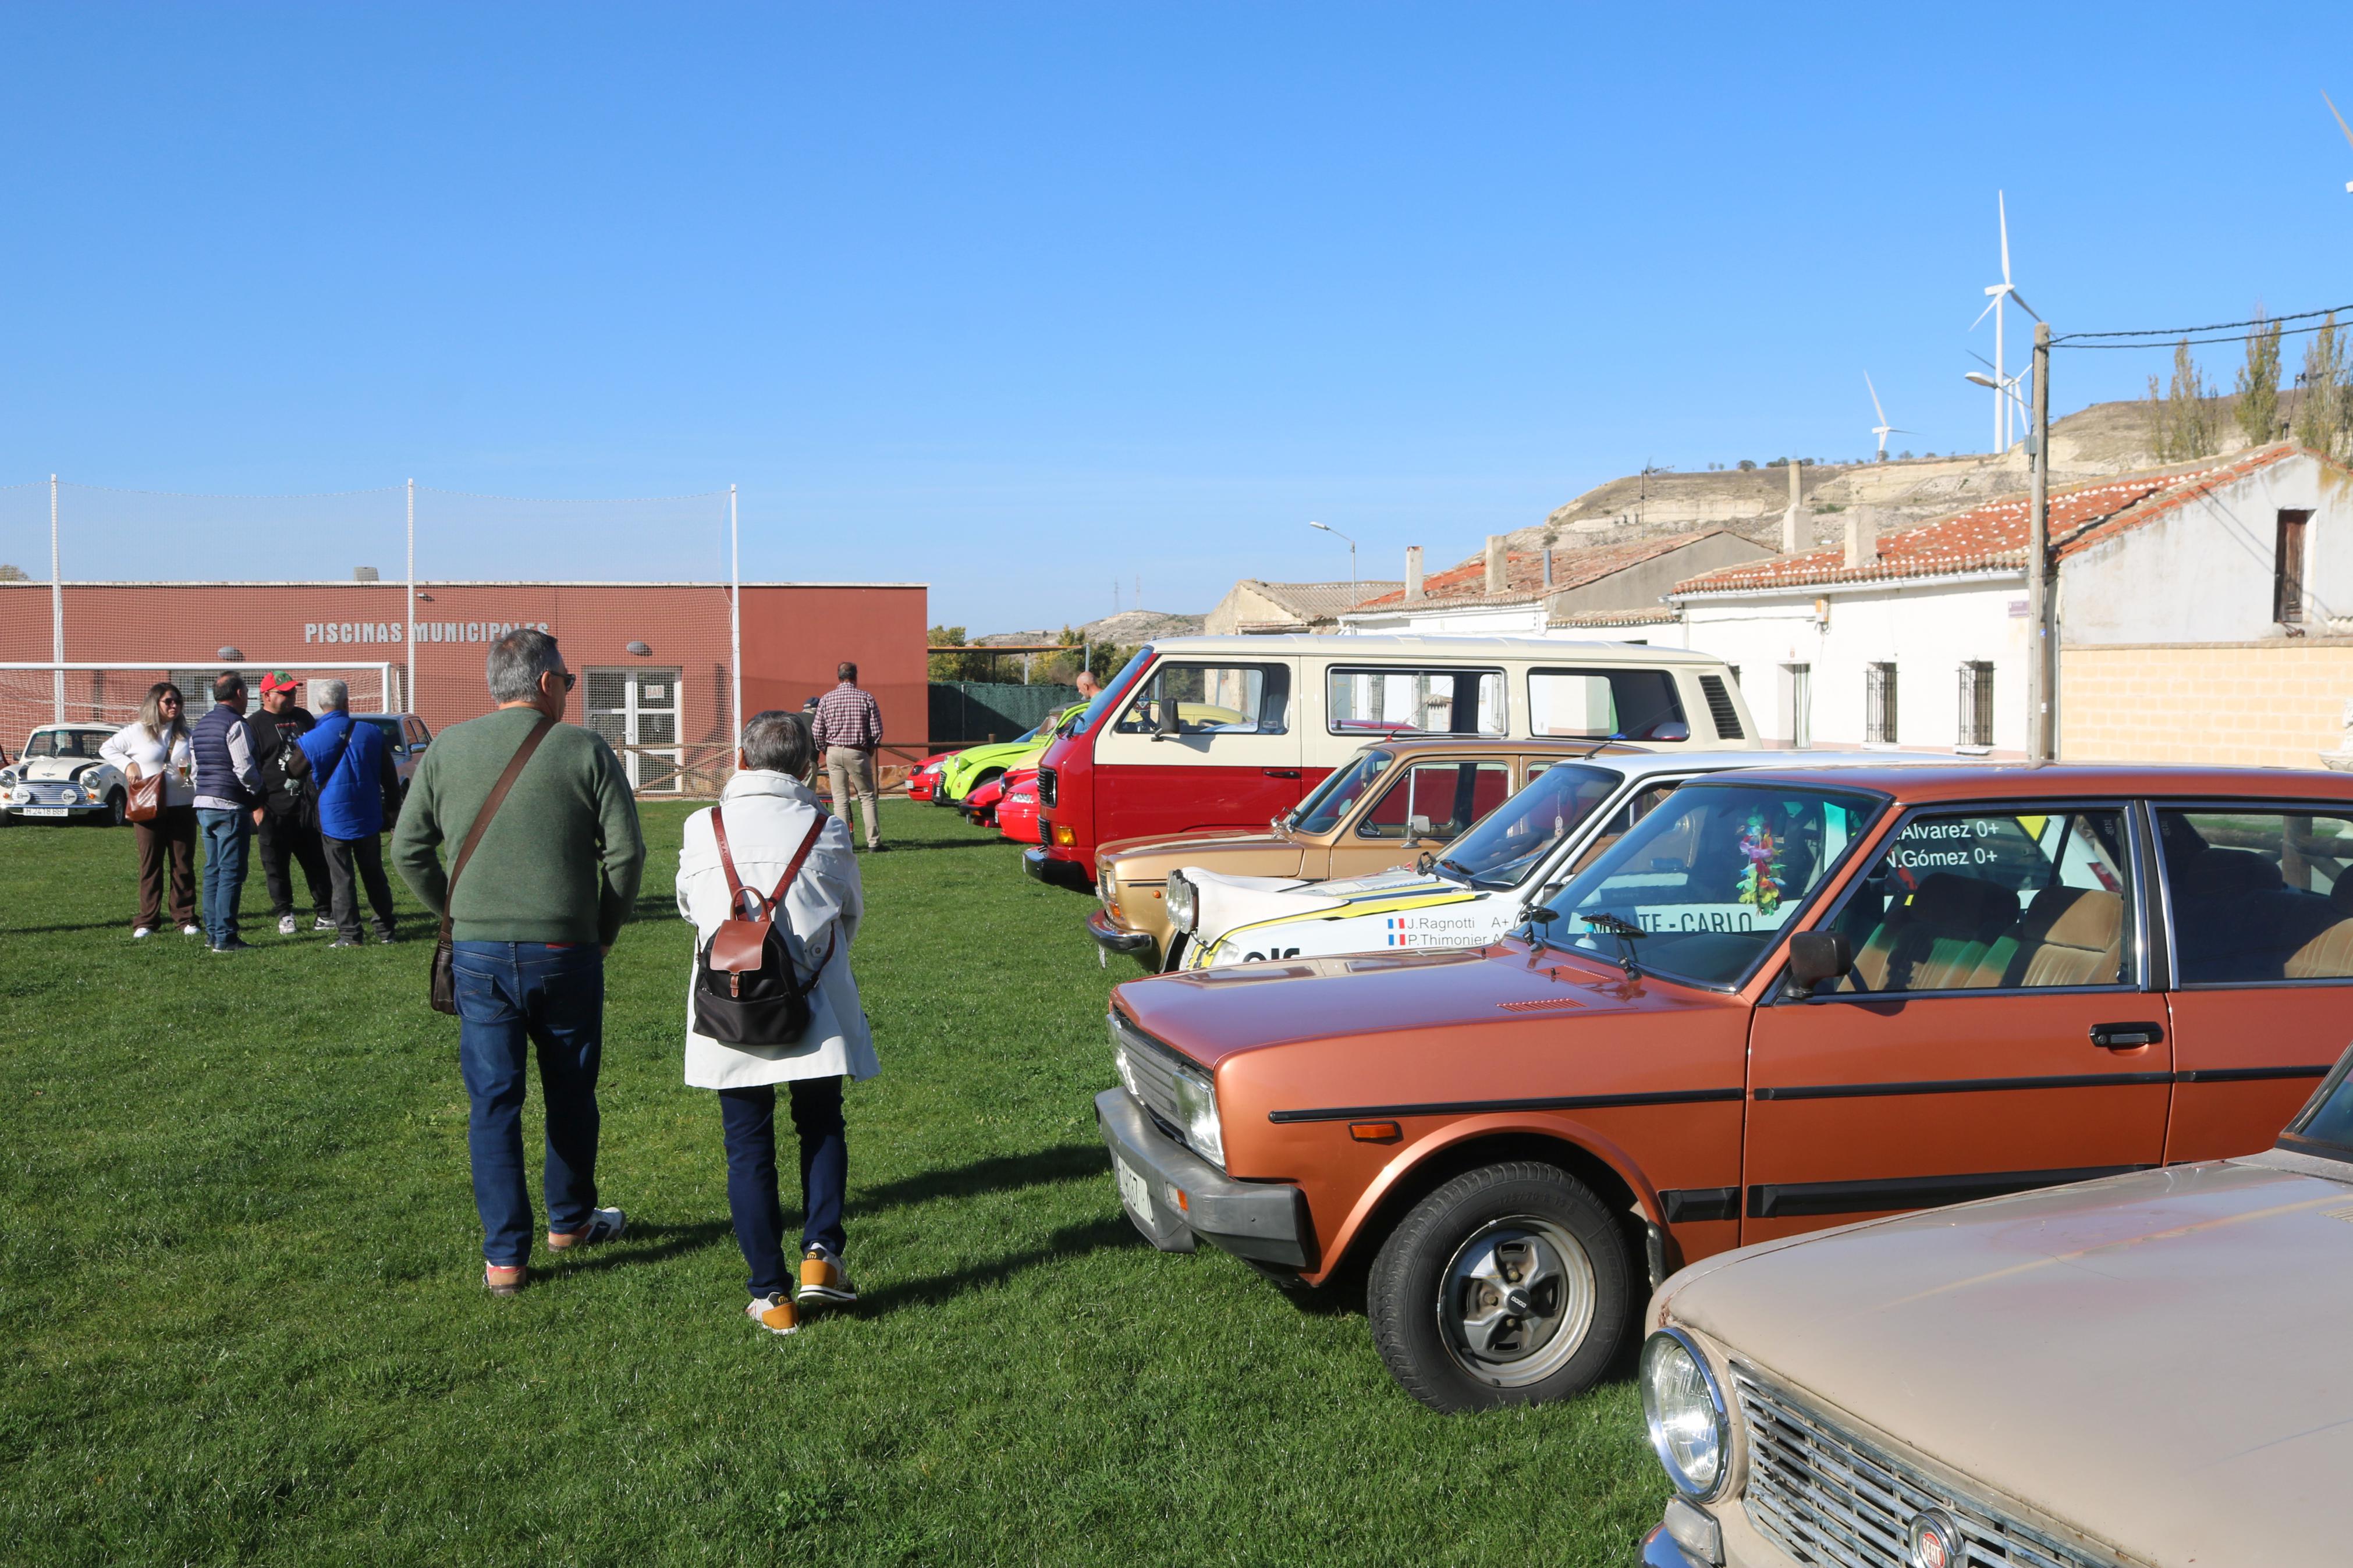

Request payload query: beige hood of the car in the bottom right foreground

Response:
[1661,1154,2353,1568]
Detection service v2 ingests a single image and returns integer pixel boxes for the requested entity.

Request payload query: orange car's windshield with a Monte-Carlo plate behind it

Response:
[1534,785,1884,987]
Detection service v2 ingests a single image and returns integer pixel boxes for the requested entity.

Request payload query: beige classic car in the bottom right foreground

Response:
[1640,1043,2353,1568]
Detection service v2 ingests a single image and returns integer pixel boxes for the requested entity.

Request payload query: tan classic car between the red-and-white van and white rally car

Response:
[1087,736,1628,969]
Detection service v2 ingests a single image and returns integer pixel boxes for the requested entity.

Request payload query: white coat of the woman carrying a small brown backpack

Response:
[677,771,882,1089]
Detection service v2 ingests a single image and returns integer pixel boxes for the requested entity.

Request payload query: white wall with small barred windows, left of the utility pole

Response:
[1685,574,2026,752]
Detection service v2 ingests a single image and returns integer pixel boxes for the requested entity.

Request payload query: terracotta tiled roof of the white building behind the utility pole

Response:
[1676,442,2304,597]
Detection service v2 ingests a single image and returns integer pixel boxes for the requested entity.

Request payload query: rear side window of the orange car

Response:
[2157,809,2353,985]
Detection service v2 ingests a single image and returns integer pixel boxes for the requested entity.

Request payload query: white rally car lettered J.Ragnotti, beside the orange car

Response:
[1167,750,1969,969]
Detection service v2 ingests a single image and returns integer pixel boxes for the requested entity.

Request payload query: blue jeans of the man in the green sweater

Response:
[452,943,605,1270]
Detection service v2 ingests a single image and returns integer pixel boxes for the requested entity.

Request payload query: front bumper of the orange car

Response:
[1094,1089,1308,1270]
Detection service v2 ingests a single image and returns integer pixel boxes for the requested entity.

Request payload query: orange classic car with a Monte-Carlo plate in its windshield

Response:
[1096,766,2353,1410]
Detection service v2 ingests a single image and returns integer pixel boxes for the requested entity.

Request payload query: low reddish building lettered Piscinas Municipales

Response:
[0,581,929,795]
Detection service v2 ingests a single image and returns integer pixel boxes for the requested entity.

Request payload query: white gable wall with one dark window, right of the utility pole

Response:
[2059,454,2353,646]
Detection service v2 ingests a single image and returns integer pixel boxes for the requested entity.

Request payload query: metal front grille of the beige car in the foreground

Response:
[1732,1366,2116,1568]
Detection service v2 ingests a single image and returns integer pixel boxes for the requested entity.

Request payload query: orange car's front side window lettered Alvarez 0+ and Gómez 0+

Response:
[1838,809,2134,992]
